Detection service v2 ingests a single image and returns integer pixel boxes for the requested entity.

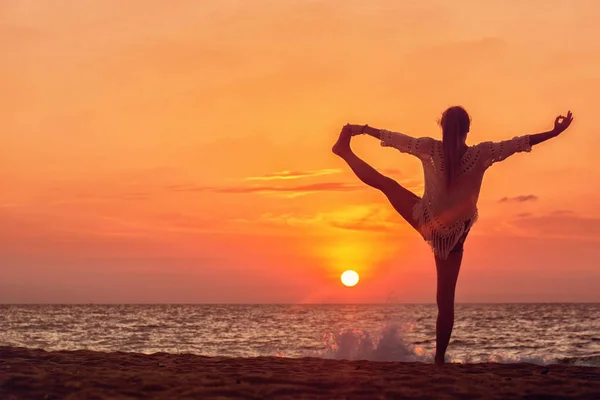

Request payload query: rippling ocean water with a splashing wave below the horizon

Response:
[0,303,600,366]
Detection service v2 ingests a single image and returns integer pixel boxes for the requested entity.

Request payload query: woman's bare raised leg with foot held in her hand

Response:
[332,125,420,229]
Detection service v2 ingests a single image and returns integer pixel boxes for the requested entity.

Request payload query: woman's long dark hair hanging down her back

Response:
[440,106,471,188]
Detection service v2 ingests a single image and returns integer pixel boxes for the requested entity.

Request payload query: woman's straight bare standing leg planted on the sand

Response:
[435,251,463,364]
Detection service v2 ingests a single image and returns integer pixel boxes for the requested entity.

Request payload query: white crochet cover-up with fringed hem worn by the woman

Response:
[366,129,531,259]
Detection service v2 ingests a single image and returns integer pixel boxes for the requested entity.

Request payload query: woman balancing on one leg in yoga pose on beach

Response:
[333,106,573,364]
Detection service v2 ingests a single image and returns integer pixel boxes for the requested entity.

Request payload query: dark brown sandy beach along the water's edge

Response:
[0,347,600,400]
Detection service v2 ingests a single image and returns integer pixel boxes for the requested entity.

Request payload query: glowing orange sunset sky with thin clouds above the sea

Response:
[0,0,600,303]
